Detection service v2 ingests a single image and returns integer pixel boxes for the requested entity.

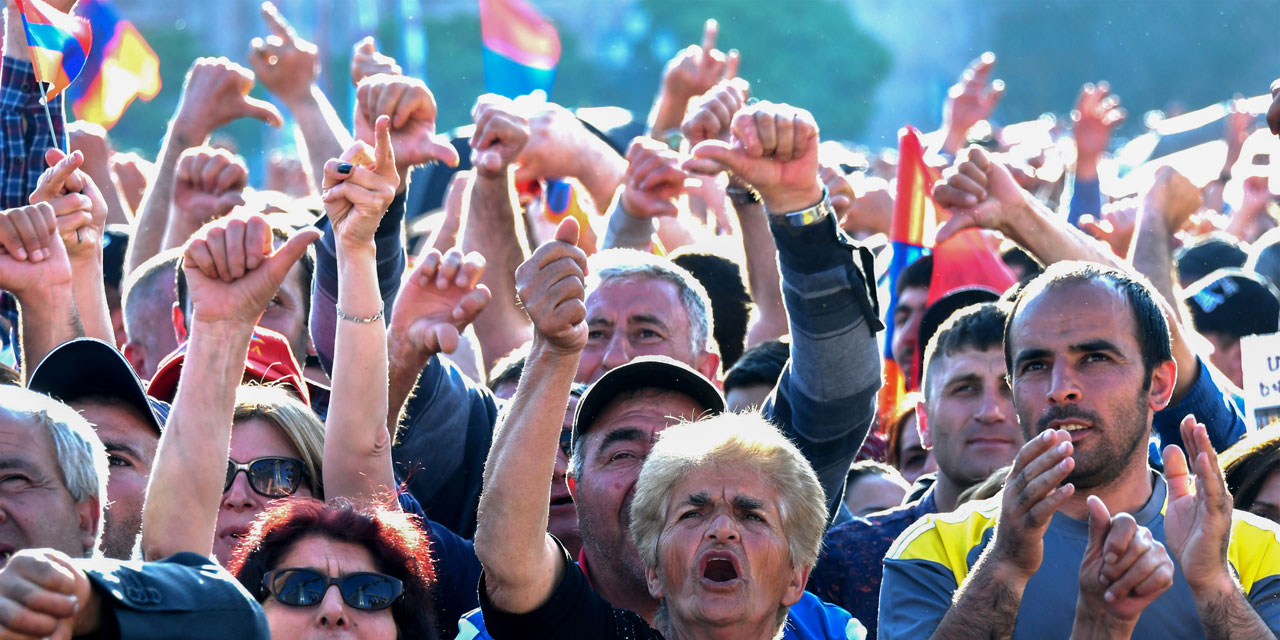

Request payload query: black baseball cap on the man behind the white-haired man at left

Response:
[27,338,169,433]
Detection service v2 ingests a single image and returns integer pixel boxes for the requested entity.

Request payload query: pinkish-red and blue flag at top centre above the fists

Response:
[480,0,561,97]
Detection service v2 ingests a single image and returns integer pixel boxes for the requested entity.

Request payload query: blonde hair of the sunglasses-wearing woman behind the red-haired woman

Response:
[232,384,324,500]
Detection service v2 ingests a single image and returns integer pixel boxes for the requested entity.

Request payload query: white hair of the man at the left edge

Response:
[0,385,109,556]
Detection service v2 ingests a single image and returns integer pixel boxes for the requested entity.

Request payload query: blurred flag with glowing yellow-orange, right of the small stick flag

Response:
[68,0,160,129]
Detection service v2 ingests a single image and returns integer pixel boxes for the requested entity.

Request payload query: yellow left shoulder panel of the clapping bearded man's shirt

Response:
[886,498,1000,573]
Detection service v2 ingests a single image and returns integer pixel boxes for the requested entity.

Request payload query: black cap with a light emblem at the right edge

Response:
[1183,269,1280,338]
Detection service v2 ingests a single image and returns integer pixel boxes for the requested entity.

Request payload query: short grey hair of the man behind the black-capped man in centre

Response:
[586,248,716,355]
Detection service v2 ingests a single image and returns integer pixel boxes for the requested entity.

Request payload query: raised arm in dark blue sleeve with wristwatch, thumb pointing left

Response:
[686,102,881,513]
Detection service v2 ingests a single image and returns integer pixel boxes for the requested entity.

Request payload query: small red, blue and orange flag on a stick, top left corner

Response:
[18,0,93,101]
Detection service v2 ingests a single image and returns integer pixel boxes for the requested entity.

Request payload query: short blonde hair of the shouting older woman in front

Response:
[631,411,827,578]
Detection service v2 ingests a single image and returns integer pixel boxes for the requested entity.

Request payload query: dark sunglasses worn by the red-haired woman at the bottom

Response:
[262,568,404,611]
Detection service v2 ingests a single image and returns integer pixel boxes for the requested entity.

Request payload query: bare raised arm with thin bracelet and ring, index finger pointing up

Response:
[324,115,399,498]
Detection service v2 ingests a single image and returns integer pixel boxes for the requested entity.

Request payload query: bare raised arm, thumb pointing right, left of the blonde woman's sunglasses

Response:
[142,215,320,559]
